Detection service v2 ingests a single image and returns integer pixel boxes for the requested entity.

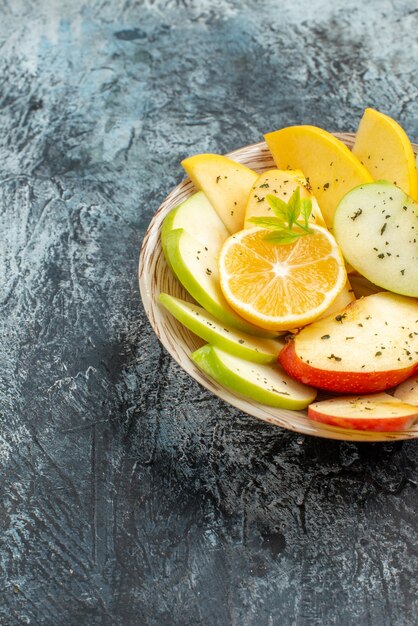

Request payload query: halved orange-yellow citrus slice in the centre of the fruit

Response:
[219,224,347,331]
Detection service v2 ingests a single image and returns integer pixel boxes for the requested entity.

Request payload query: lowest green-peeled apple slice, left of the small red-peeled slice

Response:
[191,344,316,410]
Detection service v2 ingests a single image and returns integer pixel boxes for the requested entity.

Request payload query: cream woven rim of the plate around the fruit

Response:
[138,133,418,443]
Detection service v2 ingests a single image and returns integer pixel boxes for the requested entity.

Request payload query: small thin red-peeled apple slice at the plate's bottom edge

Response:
[308,393,418,432]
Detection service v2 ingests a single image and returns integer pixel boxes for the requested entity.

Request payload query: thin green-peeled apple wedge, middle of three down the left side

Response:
[159,293,284,363]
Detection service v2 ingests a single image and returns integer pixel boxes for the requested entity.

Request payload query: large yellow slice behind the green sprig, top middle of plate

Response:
[265,126,373,228]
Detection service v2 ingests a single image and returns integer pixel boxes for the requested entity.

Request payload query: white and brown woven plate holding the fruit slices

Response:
[139,133,418,442]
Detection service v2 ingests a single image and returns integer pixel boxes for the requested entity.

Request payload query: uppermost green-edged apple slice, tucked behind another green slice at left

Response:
[161,191,229,257]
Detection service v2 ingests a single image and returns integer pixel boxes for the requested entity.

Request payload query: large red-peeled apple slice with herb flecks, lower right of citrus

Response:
[279,292,418,393]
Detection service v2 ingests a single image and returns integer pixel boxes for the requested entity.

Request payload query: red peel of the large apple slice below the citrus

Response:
[278,340,418,393]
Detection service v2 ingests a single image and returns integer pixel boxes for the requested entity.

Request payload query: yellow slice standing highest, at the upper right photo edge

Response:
[353,109,418,200]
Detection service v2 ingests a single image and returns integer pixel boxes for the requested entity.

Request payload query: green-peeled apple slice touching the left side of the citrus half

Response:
[164,228,278,337]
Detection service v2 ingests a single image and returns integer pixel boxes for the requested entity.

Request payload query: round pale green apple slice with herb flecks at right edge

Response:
[334,182,418,297]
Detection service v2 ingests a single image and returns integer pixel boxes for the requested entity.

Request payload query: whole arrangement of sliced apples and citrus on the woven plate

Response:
[142,109,418,432]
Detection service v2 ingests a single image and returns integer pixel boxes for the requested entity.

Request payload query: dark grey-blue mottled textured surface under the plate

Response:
[0,0,418,626]
